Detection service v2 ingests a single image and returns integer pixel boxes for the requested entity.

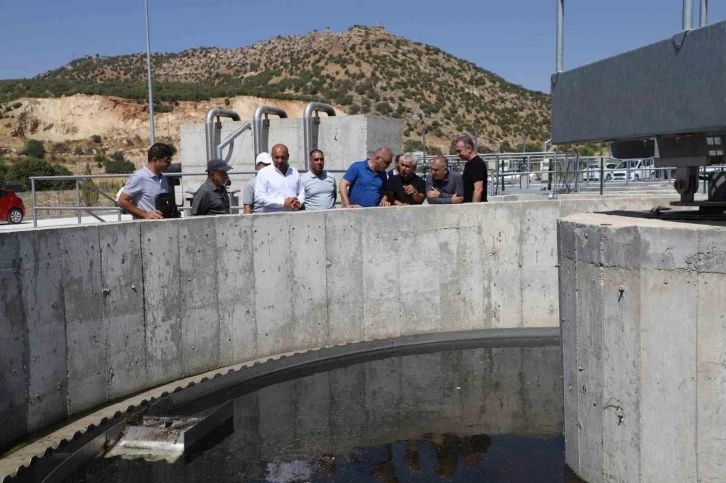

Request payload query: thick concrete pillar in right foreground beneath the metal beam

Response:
[559,214,726,483]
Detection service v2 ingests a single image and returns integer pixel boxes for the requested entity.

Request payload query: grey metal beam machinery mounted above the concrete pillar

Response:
[552,0,726,214]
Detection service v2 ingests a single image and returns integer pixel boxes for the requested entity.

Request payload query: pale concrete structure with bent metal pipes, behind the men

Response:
[181,114,403,195]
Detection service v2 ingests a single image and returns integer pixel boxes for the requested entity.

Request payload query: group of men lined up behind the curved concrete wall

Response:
[118,136,487,219]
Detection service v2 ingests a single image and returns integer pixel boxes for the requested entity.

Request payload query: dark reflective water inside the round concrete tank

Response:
[67,347,566,483]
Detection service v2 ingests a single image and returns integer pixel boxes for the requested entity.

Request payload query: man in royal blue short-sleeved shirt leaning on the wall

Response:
[340,146,393,208]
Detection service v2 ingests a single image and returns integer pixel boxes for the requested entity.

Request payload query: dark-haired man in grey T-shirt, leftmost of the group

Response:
[117,143,178,220]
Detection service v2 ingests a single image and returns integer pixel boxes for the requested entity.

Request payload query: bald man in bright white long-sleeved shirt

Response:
[255,144,305,213]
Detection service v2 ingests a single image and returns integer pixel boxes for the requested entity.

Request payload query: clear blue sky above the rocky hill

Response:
[0,0,726,92]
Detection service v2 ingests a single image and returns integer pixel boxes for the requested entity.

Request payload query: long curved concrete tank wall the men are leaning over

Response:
[0,197,667,448]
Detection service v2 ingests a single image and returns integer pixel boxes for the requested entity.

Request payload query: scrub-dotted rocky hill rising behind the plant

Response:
[0,26,550,151]
